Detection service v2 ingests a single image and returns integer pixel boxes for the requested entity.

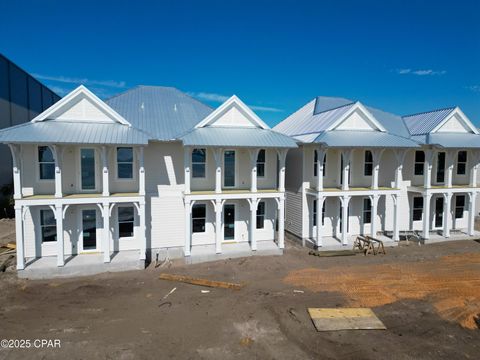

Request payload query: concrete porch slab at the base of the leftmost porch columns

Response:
[18,250,145,279]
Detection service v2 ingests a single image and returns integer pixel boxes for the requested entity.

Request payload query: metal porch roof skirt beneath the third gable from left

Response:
[313,130,419,148]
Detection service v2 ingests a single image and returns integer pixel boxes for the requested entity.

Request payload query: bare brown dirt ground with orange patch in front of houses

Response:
[0,228,480,359]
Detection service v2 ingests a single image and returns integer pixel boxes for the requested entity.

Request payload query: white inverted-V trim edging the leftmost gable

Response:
[32,85,131,126]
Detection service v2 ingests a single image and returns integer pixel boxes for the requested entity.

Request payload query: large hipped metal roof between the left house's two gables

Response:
[109,86,213,140]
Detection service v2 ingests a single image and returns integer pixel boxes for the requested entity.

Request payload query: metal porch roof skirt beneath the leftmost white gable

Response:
[0,120,150,145]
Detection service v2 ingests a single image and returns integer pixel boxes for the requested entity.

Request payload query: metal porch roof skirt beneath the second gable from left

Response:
[180,126,297,148]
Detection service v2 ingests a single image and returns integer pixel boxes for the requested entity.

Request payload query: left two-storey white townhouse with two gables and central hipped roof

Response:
[0,86,296,270]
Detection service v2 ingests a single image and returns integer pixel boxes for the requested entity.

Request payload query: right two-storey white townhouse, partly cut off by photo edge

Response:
[274,97,480,249]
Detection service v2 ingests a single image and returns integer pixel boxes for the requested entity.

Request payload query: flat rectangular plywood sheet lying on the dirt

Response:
[308,308,386,331]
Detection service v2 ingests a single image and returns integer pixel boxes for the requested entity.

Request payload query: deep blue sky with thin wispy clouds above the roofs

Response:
[0,0,480,125]
